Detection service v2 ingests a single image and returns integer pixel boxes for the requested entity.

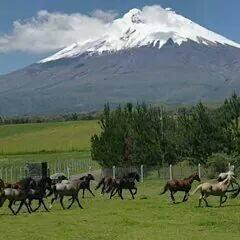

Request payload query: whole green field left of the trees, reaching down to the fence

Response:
[0,120,100,172]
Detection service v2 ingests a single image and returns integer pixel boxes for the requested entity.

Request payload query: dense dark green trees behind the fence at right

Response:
[91,93,240,167]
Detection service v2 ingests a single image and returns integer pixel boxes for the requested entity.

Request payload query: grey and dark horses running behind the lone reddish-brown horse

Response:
[0,173,140,215]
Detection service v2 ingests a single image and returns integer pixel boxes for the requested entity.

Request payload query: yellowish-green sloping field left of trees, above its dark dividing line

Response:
[0,120,99,155]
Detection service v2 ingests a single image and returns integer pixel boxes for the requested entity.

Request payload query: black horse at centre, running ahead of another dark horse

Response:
[107,172,140,200]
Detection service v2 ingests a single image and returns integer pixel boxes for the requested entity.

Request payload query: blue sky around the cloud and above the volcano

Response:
[0,0,240,74]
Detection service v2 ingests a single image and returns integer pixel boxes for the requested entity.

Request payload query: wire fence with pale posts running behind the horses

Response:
[0,159,232,182]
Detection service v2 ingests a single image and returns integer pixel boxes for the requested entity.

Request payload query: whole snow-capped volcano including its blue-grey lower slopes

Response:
[0,9,240,115]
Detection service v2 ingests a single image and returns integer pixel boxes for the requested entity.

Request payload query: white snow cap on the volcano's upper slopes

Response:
[40,7,240,63]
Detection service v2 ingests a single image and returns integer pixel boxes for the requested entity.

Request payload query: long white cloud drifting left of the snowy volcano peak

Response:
[0,10,117,53]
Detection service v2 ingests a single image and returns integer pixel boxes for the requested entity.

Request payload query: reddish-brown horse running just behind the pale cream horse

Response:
[161,173,201,203]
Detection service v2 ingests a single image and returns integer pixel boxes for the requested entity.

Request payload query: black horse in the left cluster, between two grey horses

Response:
[28,177,52,212]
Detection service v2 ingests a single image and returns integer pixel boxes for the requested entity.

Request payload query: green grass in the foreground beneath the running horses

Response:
[0,180,240,240]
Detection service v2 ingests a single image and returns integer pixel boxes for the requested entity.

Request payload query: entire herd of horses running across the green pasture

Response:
[0,167,240,215]
